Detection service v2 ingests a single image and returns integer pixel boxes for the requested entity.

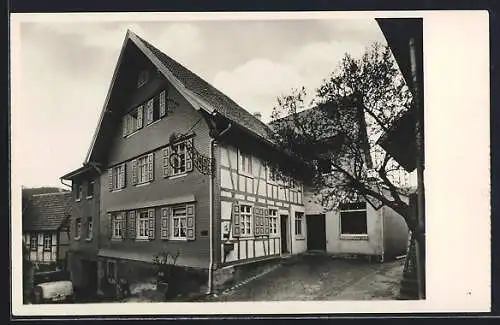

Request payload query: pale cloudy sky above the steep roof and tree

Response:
[13,19,385,187]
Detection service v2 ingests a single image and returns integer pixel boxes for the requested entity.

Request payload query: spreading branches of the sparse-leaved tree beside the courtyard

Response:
[270,43,416,230]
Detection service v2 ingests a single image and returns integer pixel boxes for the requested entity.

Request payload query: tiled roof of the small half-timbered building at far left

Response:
[23,192,72,231]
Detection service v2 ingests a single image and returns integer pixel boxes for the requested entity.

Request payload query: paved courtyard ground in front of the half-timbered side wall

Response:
[208,255,404,301]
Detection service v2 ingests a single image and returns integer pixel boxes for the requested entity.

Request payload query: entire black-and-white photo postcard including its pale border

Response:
[11,12,489,315]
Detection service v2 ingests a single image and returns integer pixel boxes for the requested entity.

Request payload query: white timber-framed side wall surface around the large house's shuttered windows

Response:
[219,144,307,263]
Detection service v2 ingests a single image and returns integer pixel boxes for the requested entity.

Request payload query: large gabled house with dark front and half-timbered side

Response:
[62,31,408,291]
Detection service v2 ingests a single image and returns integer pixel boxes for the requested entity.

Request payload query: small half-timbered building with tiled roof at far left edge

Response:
[22,191,71,268]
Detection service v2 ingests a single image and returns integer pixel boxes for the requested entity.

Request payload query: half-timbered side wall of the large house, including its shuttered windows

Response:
[220,144,305,264]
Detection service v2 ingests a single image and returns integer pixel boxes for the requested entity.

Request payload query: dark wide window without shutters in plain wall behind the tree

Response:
[339,202,368,235]
